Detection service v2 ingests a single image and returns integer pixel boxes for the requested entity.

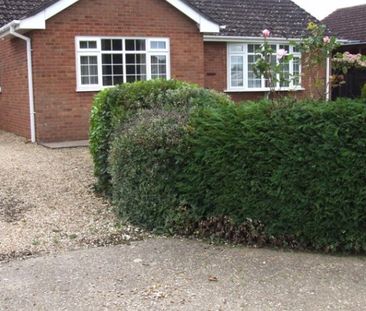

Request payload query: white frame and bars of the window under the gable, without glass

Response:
[75,36,171,92]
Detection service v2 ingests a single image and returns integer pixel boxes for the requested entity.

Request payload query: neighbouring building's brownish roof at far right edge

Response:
[323,4,366,42]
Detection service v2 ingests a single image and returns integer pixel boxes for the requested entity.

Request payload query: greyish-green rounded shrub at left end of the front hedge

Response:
[111,109,187,231]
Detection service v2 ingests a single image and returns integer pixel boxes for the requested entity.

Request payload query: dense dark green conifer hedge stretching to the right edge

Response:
[178,100,366,252]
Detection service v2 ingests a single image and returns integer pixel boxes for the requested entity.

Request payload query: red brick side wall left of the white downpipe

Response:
[0,39,30,138]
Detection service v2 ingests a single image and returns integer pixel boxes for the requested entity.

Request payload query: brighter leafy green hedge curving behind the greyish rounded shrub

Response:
[89,80,229,195]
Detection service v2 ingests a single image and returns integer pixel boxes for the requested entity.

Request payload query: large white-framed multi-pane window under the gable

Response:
[76,37,170,91]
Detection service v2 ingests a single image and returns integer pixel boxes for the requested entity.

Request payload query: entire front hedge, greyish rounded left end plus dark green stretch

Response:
[111,97,366,252]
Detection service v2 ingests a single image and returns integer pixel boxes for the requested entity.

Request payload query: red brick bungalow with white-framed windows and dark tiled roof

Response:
[0,0,316,142]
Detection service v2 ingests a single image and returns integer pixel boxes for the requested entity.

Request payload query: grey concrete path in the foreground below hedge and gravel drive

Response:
[0,238,366,311]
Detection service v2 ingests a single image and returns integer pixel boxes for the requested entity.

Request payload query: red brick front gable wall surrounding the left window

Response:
[31,0,204,141]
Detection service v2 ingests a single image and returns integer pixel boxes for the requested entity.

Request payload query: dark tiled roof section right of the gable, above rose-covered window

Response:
[186,0,319,38]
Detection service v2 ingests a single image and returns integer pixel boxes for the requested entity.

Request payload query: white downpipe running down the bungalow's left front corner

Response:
[8,25,36,143]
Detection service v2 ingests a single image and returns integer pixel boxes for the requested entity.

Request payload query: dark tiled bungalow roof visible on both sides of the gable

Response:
[0,0,318,38]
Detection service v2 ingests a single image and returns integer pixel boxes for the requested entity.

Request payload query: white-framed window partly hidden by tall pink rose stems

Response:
[228,43,301,91]
